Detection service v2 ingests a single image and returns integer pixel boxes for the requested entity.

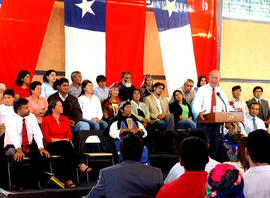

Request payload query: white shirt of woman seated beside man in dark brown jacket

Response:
[78,95,103,120]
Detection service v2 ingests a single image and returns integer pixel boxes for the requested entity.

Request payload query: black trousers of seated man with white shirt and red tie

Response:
[5,141,48,186]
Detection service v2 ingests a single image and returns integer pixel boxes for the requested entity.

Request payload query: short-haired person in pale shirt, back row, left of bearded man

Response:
[94,75,109,103]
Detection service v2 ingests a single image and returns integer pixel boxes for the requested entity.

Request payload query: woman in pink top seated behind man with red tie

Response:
[26,81,48,124]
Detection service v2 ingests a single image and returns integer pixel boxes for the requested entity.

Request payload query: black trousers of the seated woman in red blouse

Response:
[45,141,80,181]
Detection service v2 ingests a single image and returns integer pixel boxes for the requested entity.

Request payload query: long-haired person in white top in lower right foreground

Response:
[226,137,249,173]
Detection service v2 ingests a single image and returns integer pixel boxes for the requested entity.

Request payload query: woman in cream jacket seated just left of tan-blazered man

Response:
[131,89,150,128]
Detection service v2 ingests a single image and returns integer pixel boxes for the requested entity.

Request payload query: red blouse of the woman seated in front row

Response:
[41,115,72,145]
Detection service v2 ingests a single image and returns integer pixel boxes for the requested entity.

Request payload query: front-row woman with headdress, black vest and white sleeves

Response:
[109,101,148,163]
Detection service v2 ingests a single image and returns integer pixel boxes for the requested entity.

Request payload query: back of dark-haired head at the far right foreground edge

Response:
[246,129,270,166]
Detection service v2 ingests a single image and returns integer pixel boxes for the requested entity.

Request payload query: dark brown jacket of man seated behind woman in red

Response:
[48,92,82,123]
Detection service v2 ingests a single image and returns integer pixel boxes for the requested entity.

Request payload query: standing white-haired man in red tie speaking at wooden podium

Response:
[193,70,233,162]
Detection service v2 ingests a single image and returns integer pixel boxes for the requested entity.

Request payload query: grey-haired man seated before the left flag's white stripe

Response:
[68,71,82,98]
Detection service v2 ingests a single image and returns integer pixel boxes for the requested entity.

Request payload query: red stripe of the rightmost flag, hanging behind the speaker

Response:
[187,0,217,77]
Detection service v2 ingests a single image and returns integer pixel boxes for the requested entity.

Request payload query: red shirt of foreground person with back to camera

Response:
[156,171,207,198]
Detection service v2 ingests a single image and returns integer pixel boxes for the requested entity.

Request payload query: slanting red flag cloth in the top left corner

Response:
[0,0,54,87]
